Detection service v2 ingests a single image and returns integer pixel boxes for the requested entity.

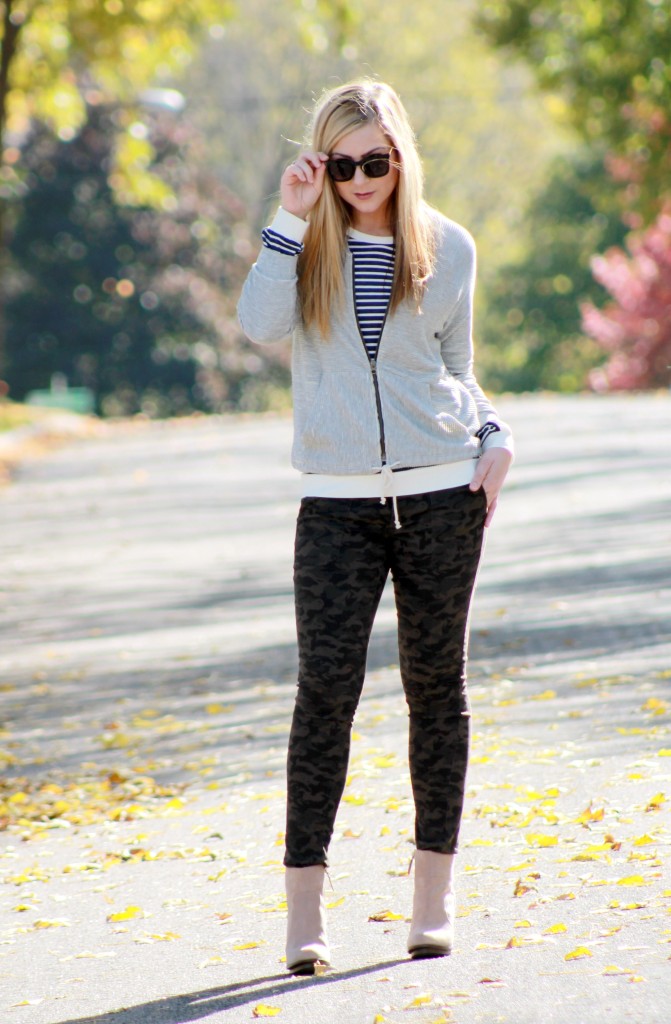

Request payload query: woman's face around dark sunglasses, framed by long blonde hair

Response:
[329,122,399,231]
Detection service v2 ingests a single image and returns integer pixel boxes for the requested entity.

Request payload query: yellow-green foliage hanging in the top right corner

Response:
[477,0,671,222]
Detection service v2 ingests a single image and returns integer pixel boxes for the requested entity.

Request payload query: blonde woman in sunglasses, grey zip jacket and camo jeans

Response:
[239,82,512,974]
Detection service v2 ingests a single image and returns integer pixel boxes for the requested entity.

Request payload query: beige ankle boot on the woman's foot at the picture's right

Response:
[408,850,455,959]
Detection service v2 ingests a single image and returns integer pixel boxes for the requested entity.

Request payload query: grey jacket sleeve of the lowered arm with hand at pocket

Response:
[436,227,514,455]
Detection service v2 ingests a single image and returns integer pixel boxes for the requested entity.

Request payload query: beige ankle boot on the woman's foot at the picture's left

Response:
[286,864,331,974]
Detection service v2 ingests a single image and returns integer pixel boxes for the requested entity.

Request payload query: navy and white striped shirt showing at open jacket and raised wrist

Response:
[261,227,395,359]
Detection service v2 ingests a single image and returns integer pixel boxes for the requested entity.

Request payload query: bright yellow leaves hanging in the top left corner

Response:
[0,0,233,374]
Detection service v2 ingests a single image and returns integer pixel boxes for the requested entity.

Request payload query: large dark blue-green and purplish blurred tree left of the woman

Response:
[7,105,286,416]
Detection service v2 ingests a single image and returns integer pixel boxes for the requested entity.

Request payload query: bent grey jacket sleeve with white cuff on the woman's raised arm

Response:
[238,207,307,345]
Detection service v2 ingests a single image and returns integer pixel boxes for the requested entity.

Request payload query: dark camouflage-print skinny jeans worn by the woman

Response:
[284,486,487,867]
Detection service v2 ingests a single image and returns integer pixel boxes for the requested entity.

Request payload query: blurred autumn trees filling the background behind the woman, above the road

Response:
[0,0,671,426]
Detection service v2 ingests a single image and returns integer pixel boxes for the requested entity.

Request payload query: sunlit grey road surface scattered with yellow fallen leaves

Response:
[0,398,671,1024]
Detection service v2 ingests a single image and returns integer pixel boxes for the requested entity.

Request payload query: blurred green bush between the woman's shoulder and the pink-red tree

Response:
[479,153,625,391]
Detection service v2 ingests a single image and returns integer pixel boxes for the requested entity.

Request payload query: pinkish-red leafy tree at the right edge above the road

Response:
[582,207,671,391]
